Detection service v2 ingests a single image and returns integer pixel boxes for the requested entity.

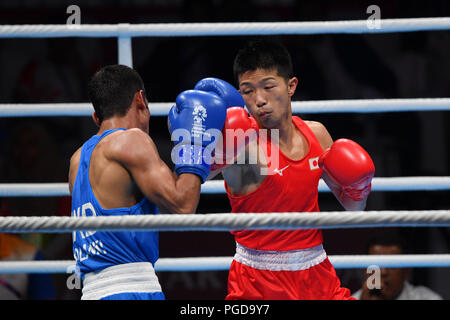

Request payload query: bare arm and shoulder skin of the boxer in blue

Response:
[69,129,201,213]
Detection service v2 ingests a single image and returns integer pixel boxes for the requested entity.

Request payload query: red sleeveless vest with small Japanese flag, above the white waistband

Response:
[225,116,323,251]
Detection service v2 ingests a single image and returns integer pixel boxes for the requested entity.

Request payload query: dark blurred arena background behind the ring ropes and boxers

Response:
[0,0,450,300]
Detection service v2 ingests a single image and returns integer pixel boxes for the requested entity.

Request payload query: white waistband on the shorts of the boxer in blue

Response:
[81,262,162,300]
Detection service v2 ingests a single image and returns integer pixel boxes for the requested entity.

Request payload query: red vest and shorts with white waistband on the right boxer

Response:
[225,117,352,300]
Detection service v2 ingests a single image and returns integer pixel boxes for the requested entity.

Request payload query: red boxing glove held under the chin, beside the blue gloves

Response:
[211,107,258,171]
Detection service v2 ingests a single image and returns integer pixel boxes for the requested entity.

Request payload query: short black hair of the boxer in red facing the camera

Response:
[233,39,294,83]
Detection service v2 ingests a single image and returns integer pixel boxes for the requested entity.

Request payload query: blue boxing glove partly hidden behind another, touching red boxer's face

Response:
[194,78,245,108]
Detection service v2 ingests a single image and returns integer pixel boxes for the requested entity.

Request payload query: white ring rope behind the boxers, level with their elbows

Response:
[0,177,450,197]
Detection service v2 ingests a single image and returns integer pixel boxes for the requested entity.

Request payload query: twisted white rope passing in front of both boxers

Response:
[0,210,450,233]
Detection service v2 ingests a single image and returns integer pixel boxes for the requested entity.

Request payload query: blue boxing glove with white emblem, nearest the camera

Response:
[168,90,227,183]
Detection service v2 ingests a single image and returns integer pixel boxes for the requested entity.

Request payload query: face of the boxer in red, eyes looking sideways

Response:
[239,69,298,129]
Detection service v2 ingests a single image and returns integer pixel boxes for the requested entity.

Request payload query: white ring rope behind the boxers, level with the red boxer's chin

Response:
[0,98,450,118]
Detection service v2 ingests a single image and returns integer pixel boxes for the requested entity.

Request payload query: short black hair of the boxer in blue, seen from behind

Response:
[88,64,149,122]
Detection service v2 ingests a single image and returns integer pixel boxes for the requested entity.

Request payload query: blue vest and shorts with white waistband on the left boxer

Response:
[72,129,165,300]
